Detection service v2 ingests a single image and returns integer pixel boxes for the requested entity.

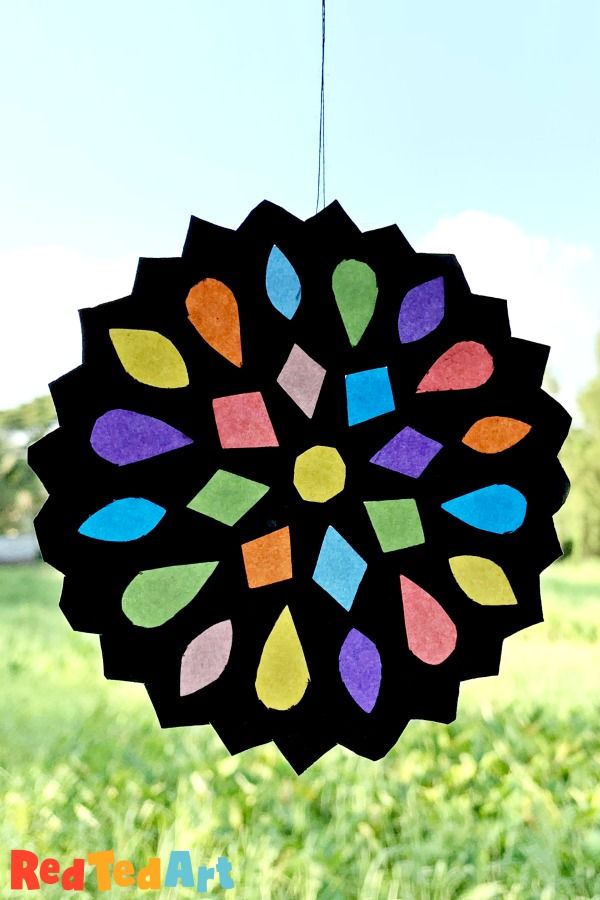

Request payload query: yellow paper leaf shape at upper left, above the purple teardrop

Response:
[109,328,189,388]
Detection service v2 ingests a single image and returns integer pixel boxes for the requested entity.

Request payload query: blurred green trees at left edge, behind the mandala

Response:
[0,397,56,534]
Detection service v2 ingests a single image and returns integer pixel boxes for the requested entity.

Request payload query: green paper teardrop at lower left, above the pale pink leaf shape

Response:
[123,562,219,628]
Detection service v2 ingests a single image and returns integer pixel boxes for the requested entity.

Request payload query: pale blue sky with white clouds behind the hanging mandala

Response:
[0,0,600,406]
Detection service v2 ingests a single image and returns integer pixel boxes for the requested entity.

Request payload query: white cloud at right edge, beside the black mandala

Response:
[417,211,600,413]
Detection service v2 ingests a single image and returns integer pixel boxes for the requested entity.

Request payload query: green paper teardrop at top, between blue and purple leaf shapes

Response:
[331,259,378,347]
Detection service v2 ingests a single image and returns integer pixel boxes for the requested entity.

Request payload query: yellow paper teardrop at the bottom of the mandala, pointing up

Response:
[256,606,310,709]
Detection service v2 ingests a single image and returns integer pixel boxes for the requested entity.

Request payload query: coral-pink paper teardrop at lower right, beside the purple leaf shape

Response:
[400,575,456,666]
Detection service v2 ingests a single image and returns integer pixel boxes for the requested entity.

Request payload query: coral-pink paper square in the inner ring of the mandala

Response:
[213,391,279,450]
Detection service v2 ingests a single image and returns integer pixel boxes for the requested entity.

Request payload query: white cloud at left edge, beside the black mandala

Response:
[0,246,137,409]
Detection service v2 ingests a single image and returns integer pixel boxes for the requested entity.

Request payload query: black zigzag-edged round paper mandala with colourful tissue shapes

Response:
[31,203,569,771]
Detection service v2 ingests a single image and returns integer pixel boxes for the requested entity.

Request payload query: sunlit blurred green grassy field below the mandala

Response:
[0,563,600,900]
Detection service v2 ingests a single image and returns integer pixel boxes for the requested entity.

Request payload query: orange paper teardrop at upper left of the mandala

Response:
[185,278,242,368]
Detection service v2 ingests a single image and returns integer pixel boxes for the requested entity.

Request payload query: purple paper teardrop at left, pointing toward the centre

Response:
[90,409,193,466]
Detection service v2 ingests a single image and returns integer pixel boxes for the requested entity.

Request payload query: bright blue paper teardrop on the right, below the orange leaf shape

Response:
[442,484,527,534]
